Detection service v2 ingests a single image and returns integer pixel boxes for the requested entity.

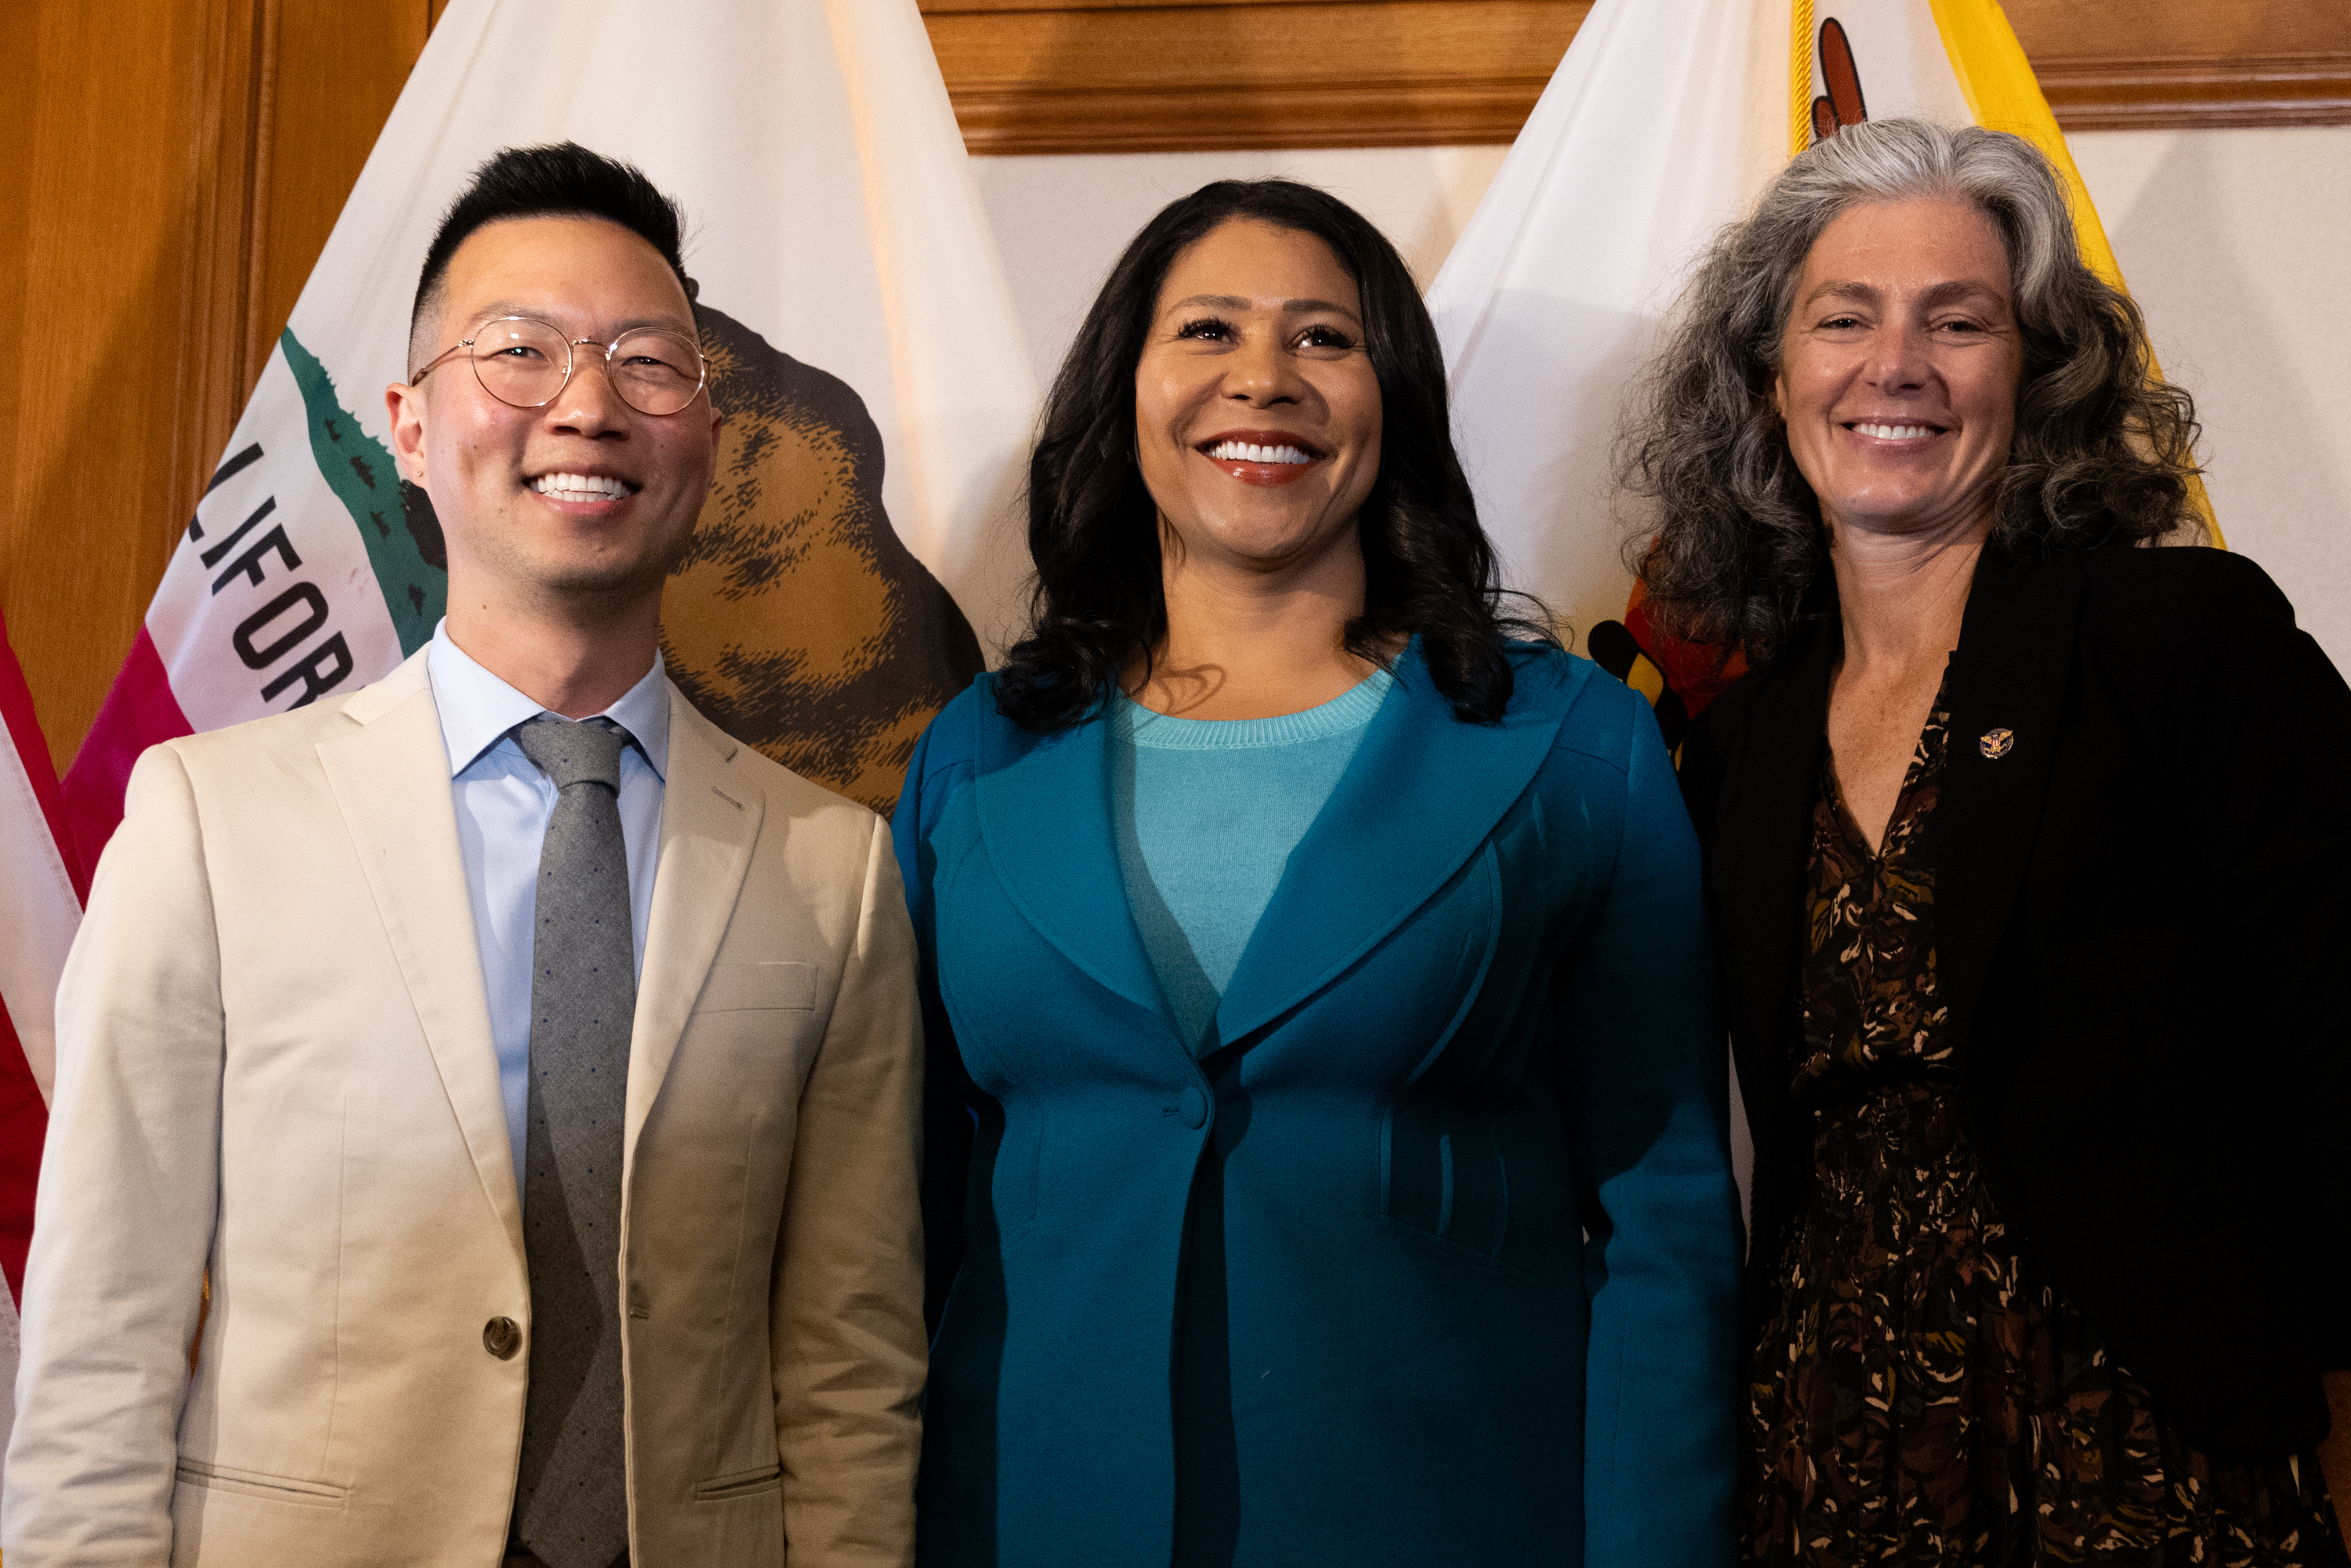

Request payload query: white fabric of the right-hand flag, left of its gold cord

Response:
[1429,0,1789,654]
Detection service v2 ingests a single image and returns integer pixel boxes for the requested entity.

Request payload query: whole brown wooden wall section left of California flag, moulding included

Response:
[0,0,433,766]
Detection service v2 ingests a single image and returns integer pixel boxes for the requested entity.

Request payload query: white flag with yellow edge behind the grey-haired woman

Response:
[1429,0,2219,743]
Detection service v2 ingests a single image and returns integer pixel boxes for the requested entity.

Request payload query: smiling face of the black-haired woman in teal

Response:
[1136,219,1380,583]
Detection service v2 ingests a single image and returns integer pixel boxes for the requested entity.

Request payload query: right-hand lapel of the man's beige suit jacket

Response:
[625,686,766,1159]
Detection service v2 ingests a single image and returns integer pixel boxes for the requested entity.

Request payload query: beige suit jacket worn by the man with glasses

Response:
[0,654,924,1568]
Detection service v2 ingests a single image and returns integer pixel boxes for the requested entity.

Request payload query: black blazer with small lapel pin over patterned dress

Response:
[1683,548,2351,1458]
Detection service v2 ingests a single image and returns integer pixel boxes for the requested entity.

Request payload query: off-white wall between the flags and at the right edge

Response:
[973,127,2351,677]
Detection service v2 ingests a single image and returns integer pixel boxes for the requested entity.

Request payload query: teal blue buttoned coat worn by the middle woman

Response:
[896,651,1737,1568]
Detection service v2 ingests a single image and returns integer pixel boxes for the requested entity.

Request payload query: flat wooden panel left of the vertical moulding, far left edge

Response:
[0,0,226,780]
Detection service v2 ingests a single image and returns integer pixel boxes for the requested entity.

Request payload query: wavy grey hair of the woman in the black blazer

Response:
[1617,120,2203,663]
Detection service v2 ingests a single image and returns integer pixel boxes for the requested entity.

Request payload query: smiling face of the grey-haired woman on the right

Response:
[1773,197,2024,538]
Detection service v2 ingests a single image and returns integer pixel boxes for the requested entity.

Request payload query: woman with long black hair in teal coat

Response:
[896,181,1737,1568]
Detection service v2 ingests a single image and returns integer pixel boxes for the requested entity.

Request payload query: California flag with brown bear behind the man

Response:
[66,0,1037,860]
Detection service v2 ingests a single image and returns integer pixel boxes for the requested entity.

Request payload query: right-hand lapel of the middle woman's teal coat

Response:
[1215,642,1594,1041]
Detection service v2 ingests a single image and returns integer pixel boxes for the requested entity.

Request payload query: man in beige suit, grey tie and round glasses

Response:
[0,146,924,1568]
